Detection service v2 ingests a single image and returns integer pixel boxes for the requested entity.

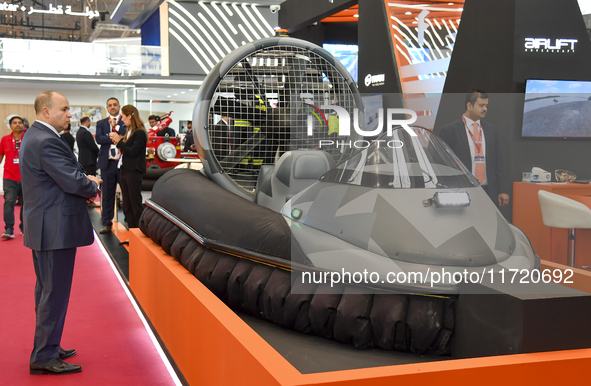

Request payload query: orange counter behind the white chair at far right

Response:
[513,182,591,266]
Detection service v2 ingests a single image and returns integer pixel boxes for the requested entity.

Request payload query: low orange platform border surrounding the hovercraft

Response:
[129,229,591,386]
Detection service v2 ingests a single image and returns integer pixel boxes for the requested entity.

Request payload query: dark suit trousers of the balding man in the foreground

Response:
[31,248,76,365]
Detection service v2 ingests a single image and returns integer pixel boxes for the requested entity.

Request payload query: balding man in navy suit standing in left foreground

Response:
[19,91,101,374]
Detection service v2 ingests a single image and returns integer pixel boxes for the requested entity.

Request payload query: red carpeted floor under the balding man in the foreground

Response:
[0,206,180,386]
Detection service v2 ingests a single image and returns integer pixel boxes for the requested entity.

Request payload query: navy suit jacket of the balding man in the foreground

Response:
[19,121,98,251]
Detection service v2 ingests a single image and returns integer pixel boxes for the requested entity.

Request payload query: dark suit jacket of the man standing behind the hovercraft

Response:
[438,119,510,205]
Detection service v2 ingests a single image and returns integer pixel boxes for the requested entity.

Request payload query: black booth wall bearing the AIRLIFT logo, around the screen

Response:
[435,0,591,219]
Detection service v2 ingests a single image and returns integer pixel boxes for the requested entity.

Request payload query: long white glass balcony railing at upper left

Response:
[0,38,168,76]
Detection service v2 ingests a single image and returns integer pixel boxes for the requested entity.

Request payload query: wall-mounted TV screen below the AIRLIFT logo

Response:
[521,79,591,138]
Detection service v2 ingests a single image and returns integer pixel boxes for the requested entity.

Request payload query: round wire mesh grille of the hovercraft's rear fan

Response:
[208,46,357,194]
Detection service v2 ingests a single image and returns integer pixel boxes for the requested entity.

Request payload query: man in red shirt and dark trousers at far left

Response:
[0,115,25,240]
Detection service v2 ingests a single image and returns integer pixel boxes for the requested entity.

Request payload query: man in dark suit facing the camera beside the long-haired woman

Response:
[96,98,127,234]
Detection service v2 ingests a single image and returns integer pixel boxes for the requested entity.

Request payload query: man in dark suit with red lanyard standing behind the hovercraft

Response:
[436,90,510,206]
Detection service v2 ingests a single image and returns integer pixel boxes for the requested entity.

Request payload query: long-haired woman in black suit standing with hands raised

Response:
[109,105,148,228]
